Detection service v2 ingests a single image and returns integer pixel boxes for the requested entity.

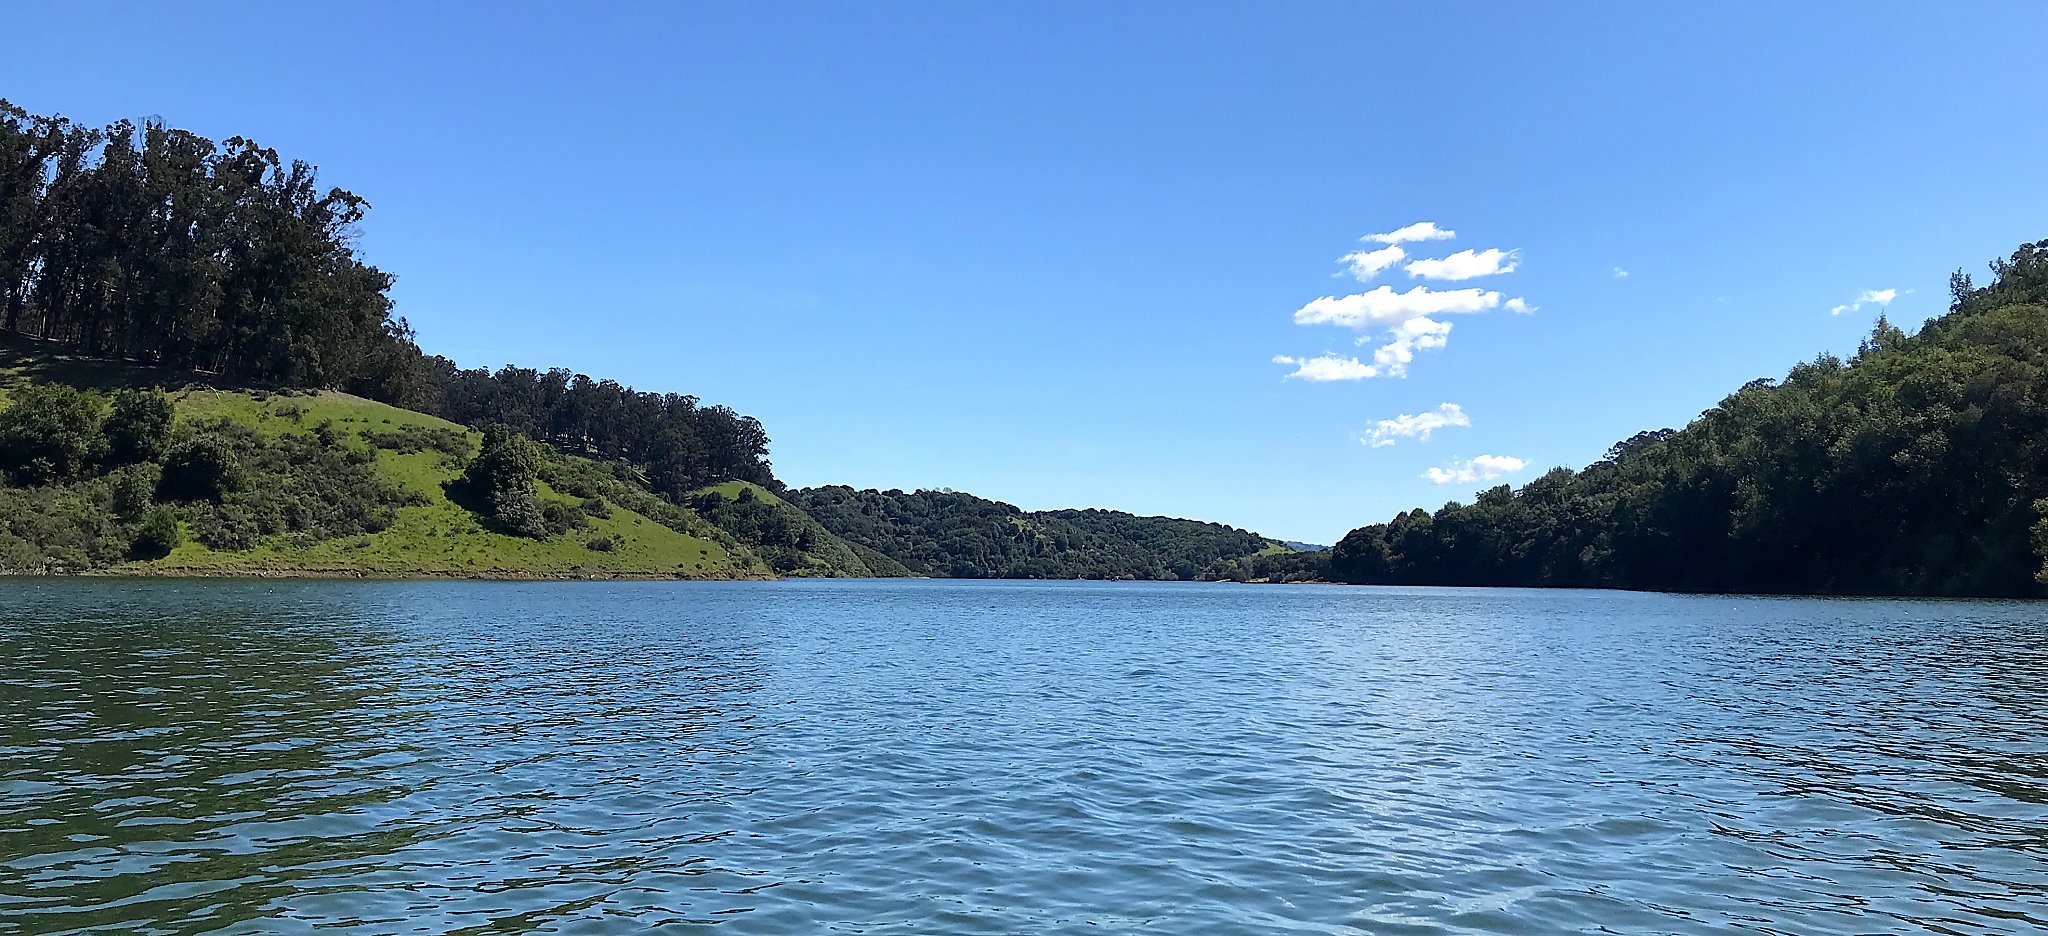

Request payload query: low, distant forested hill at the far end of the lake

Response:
[788,485,1286,580]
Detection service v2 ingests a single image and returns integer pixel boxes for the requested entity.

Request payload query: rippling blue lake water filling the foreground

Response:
[0,580,2048,934]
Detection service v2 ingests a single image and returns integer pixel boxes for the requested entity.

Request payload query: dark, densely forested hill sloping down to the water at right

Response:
[1331,242,2048,596]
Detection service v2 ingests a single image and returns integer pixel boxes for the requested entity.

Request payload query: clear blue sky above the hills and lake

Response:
[0,2,2048,543]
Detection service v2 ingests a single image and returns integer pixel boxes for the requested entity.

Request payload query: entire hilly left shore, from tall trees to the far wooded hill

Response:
[0,100,1318,580]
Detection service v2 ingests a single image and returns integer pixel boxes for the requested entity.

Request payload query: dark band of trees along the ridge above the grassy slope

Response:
[0,100,780,500]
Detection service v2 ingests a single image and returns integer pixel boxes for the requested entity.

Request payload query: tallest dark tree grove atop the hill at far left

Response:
[0,102,408,385]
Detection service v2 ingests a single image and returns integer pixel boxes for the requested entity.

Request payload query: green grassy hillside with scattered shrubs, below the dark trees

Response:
[0,340,770,578]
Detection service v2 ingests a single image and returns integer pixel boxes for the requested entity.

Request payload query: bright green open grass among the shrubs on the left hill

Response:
[115,389,766,578]
